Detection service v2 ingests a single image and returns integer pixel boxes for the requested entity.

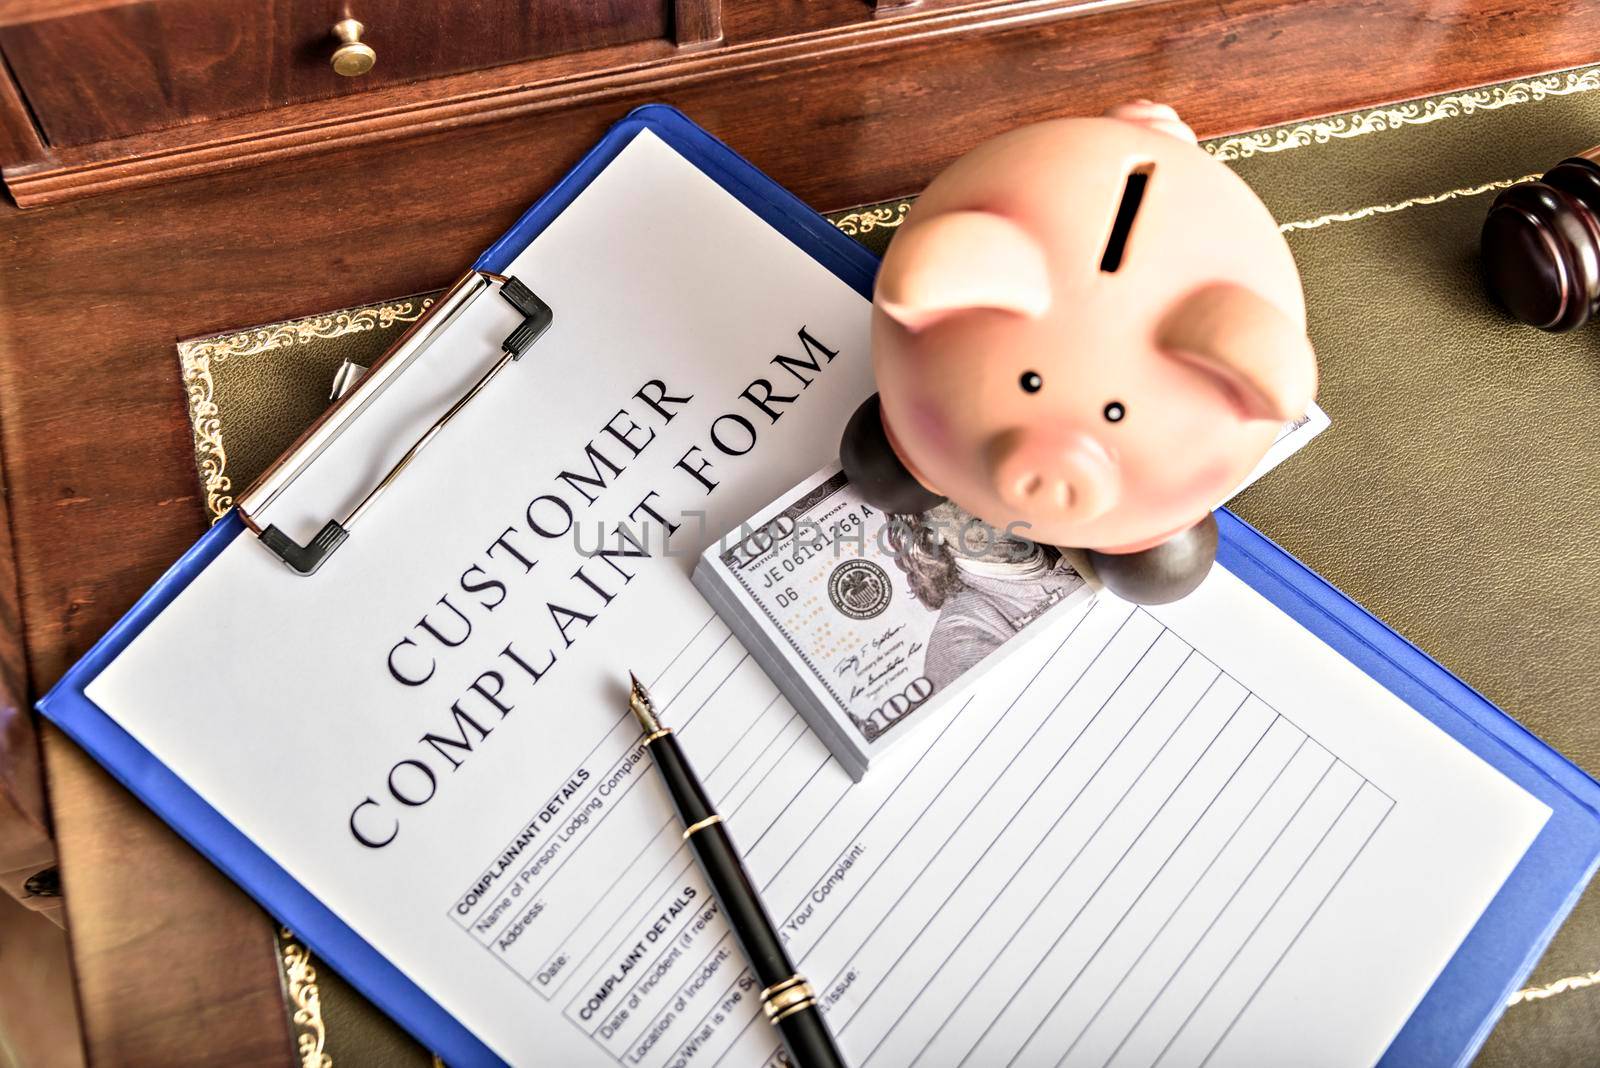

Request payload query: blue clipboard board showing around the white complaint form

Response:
[38,106,1600,1066]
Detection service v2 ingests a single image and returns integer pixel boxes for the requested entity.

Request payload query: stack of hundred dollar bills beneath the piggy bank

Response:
[694,404,1328,782]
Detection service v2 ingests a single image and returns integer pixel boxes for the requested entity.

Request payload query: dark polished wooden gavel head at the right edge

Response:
[1483,147,1600,331]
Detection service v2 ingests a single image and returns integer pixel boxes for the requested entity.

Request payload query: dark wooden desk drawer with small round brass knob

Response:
[0,0,672,145]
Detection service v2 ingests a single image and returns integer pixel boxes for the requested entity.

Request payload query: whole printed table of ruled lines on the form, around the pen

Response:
[458,591,1414,1065]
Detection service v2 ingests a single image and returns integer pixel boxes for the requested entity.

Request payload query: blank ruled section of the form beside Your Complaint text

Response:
[764,611,1392,1065]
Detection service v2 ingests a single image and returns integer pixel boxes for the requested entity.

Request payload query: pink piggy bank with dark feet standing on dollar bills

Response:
[840,102,1317,604]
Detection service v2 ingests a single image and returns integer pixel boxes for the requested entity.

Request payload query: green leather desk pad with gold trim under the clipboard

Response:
[179,67,1600,1068]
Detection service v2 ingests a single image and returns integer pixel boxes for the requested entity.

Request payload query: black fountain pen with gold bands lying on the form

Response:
[627,673,845,1068]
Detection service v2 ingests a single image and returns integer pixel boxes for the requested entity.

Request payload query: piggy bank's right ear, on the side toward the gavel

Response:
[1157,283,1317,422]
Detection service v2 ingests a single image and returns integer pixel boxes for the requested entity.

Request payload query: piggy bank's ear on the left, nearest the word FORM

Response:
[872,211,1050,331]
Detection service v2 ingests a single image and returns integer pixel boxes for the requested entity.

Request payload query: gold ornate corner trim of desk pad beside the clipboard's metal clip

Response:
[178,297,434,523]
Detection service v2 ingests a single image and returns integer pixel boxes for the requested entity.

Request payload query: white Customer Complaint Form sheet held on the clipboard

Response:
[88,133,1547,1066]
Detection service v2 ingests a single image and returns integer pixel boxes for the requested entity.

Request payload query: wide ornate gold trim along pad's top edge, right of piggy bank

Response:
[1202,67,1600,160]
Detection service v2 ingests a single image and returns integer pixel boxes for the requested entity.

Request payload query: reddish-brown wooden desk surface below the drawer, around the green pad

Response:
[0,0,1600,1065]
